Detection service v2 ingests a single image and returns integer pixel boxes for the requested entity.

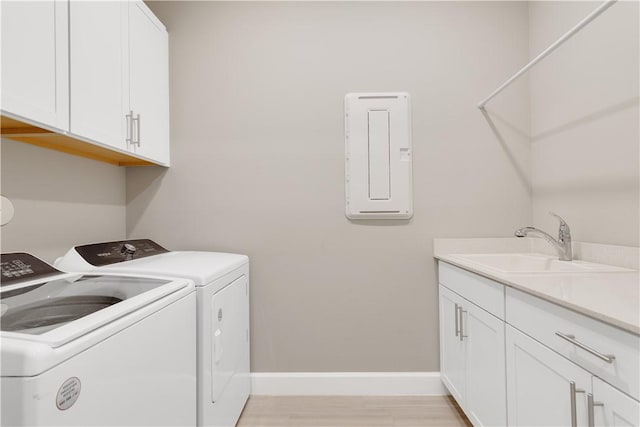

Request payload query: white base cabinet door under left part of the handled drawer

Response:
[506,325,591,427]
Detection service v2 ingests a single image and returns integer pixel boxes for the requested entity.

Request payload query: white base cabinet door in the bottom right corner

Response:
[588,377,640,427]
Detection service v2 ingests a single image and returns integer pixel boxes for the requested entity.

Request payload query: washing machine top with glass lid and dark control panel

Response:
[0,254,186,348]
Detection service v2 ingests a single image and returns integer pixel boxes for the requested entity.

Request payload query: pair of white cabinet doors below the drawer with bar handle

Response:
[507,325,640,427]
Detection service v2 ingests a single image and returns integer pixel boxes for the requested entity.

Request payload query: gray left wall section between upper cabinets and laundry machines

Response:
[0,139,126,262]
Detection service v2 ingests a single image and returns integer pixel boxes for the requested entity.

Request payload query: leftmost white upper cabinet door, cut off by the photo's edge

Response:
[0,0,69,131]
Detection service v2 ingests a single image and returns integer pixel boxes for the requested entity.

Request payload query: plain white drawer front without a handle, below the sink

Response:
[438,261,504,319]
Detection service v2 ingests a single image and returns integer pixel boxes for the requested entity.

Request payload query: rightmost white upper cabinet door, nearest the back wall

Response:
[129,1,169,166]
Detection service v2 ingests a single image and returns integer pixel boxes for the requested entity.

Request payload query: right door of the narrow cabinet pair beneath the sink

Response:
[461,302,507,426]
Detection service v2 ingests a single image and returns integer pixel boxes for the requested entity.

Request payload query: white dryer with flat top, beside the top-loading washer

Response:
[56,239,251,427]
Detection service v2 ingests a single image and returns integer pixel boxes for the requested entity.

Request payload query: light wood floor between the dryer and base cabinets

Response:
[237,396,471,427]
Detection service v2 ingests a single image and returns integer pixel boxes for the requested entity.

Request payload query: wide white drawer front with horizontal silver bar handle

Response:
[506,288,640,399]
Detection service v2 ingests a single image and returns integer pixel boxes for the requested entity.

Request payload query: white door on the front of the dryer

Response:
[211,275,249,402]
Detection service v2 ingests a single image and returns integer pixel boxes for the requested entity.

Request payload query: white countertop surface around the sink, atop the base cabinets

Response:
[434,239,640,335]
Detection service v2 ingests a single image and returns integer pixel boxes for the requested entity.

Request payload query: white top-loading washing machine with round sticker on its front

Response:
[0,253,196,426]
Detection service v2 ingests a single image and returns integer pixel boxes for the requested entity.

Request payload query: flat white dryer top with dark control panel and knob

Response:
[56,239,249,286]
